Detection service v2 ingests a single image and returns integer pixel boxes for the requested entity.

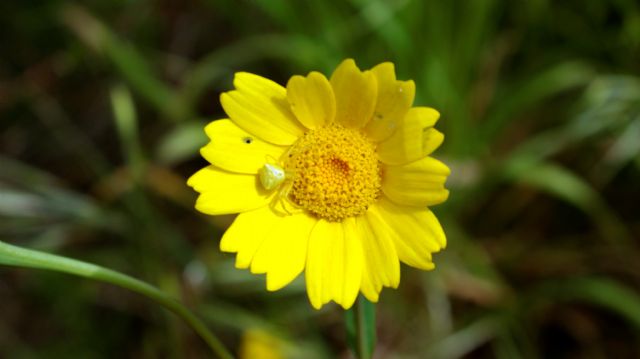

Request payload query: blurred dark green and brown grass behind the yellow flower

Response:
[0,0,640,359]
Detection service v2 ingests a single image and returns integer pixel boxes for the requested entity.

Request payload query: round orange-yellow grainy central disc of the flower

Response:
[286,124,381,222]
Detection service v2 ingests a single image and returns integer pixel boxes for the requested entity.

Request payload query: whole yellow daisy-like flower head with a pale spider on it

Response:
[188,59,449,309]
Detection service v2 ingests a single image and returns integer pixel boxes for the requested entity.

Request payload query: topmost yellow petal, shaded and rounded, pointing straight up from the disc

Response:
[331,59,378,128]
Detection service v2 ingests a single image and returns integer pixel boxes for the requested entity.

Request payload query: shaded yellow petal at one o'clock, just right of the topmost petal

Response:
[365,62,416,142]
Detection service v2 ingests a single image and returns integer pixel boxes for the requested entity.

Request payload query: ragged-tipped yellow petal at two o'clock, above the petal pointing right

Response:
[377,107,444,165]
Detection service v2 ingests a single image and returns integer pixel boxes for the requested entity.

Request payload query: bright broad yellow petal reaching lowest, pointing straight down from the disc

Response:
[305,219,362,309]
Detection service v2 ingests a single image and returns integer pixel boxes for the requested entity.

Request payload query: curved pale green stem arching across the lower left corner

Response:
[0,241,233,359]
